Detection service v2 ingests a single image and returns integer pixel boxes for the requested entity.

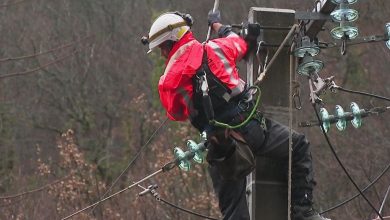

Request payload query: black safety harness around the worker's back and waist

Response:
[190,45,260,130]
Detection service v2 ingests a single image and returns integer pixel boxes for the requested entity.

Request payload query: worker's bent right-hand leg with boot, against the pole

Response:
[242,119,326,220]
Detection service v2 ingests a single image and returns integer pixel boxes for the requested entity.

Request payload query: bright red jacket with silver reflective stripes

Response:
[158,32,247,121]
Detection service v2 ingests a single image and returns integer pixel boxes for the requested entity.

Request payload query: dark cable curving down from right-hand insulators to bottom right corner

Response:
[313,105,383,220]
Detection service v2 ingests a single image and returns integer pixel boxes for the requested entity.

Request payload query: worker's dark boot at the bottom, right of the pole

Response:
[292,196,331,220]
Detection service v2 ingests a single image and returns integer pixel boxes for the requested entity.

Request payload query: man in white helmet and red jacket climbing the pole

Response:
[143,10,329,220]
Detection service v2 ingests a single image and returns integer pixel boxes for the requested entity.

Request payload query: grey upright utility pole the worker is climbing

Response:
[247,0,336,220]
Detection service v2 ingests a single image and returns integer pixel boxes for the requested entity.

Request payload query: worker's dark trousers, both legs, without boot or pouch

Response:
[209,119,315,220]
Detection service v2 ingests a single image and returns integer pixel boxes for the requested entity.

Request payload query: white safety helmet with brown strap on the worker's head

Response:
[148,12,190,53]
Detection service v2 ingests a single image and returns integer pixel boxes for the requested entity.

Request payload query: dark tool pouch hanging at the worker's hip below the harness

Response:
[207,130,255,181]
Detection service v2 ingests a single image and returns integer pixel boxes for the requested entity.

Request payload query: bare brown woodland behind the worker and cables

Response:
[0,0,390,220]
